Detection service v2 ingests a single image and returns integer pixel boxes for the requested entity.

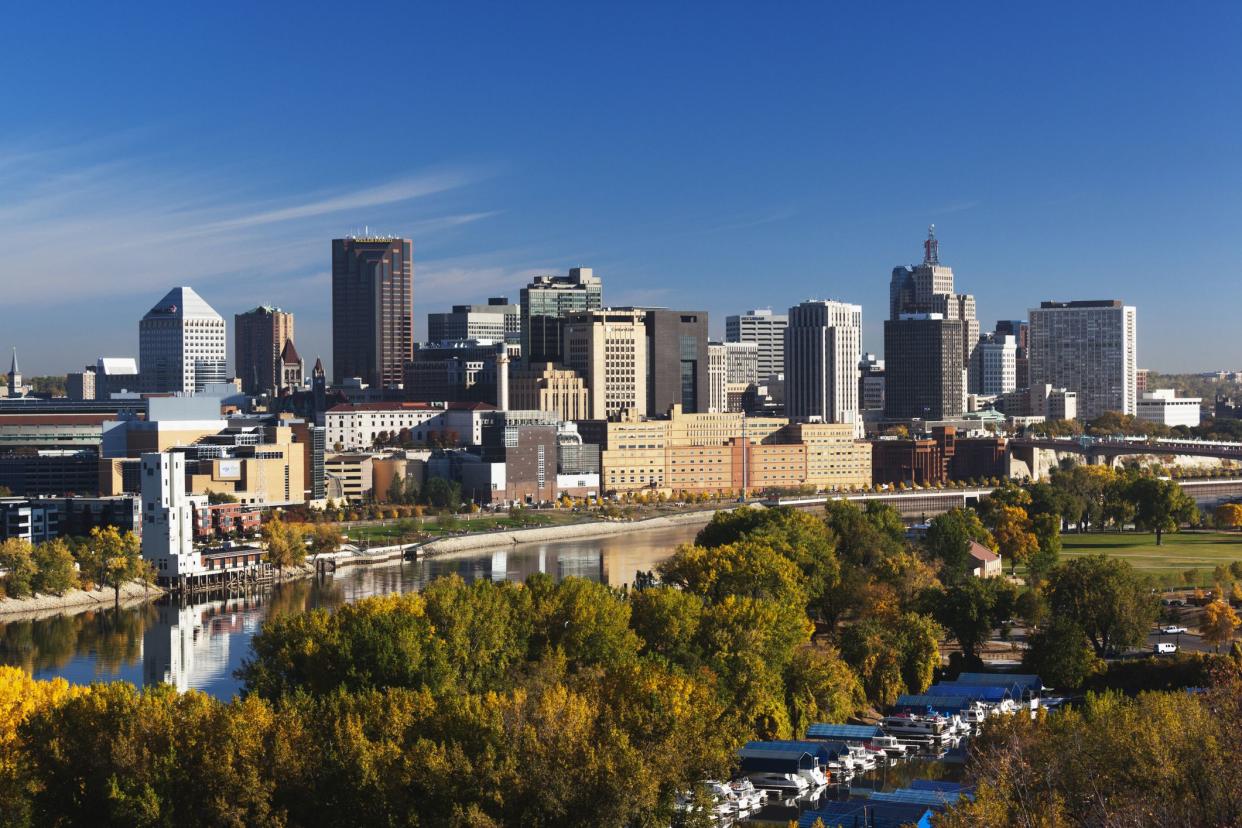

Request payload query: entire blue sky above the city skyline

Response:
[0,2,1242,375]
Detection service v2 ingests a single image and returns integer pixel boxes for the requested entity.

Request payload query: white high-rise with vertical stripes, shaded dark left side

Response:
[785,300,862,437]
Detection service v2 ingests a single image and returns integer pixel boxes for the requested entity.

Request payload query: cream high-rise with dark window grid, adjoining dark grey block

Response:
[558,308,647,420]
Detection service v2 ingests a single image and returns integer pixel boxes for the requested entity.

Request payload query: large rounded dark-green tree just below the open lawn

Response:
[1046,555,1159,658]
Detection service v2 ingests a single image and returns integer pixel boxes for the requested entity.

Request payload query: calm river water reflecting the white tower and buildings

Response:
[0,526,698,699]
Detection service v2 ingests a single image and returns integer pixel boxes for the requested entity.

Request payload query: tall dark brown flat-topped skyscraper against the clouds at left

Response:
[332,236,414,389]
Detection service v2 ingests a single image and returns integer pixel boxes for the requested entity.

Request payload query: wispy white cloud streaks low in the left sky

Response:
[0,139,497,309]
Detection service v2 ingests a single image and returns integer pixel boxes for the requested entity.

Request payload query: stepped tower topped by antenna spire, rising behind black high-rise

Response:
[884,225,979,390]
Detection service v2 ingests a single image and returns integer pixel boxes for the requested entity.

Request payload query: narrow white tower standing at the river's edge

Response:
[139,452,206,581]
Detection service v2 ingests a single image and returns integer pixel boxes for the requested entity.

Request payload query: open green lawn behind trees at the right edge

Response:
[1061,531,1242,583]
